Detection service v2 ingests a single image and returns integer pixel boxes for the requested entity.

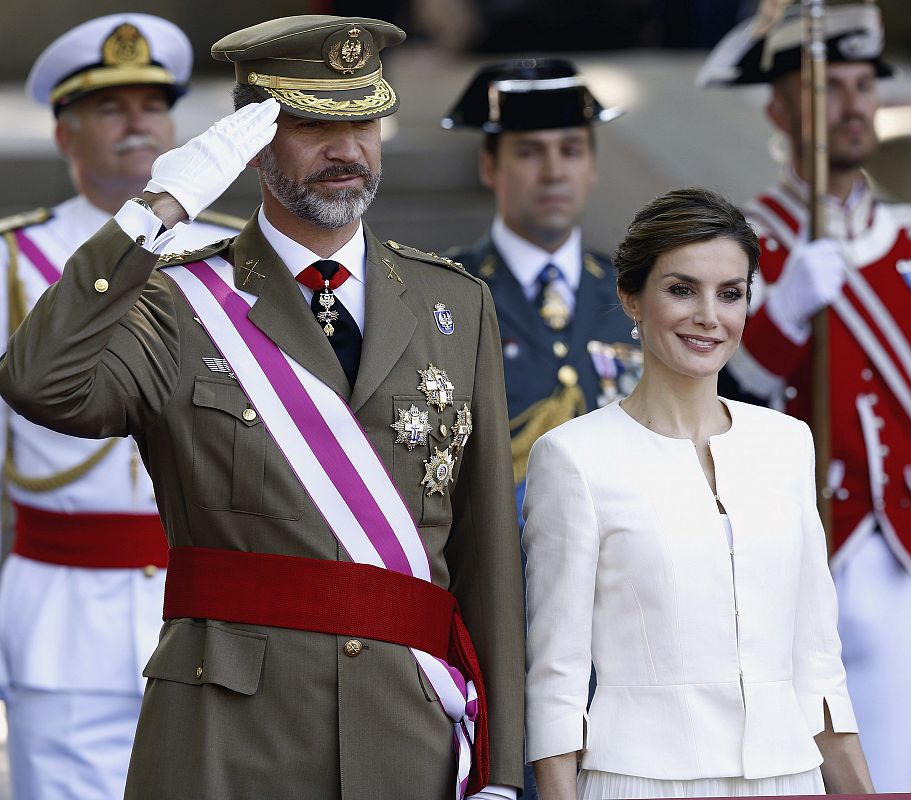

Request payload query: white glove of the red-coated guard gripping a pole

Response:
[765,239,848,344]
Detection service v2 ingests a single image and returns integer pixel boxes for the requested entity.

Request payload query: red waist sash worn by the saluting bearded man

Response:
[164,547,490,791]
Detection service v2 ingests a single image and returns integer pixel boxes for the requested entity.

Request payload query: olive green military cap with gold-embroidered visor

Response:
[212,15,405,121]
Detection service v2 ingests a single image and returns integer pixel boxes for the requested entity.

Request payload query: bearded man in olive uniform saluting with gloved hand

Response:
[0,16,524,800]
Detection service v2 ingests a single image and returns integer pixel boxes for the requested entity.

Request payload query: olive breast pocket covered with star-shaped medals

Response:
[392,395,470,526]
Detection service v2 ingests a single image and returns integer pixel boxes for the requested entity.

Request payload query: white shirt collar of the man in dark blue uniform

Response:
[490,215,582,312]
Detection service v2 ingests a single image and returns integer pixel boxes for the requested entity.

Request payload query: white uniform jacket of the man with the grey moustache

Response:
[0,196,236,697]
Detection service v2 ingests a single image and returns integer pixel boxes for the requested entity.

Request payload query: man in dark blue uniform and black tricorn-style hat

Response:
[442,59,641,511]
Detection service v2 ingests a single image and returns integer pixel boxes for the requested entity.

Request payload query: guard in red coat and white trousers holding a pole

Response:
[699,4,911,792]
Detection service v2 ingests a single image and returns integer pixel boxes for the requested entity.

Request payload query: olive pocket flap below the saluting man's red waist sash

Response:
[142,620,268,695]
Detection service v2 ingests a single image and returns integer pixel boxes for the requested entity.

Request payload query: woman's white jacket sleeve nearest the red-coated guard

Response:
[793,423,857,736]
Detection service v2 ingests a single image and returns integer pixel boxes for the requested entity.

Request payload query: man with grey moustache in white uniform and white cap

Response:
[0,14,246,799]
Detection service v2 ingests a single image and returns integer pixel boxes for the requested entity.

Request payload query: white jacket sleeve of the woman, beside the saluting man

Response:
[522,434,599,762]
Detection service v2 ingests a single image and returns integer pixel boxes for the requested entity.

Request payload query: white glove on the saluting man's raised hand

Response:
[146,97,281,220]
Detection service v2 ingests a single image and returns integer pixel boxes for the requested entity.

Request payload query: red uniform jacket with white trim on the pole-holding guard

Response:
[728,171,911,573]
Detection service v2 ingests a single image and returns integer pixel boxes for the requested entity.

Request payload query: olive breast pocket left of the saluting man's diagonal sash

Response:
[193,376,302,519]
